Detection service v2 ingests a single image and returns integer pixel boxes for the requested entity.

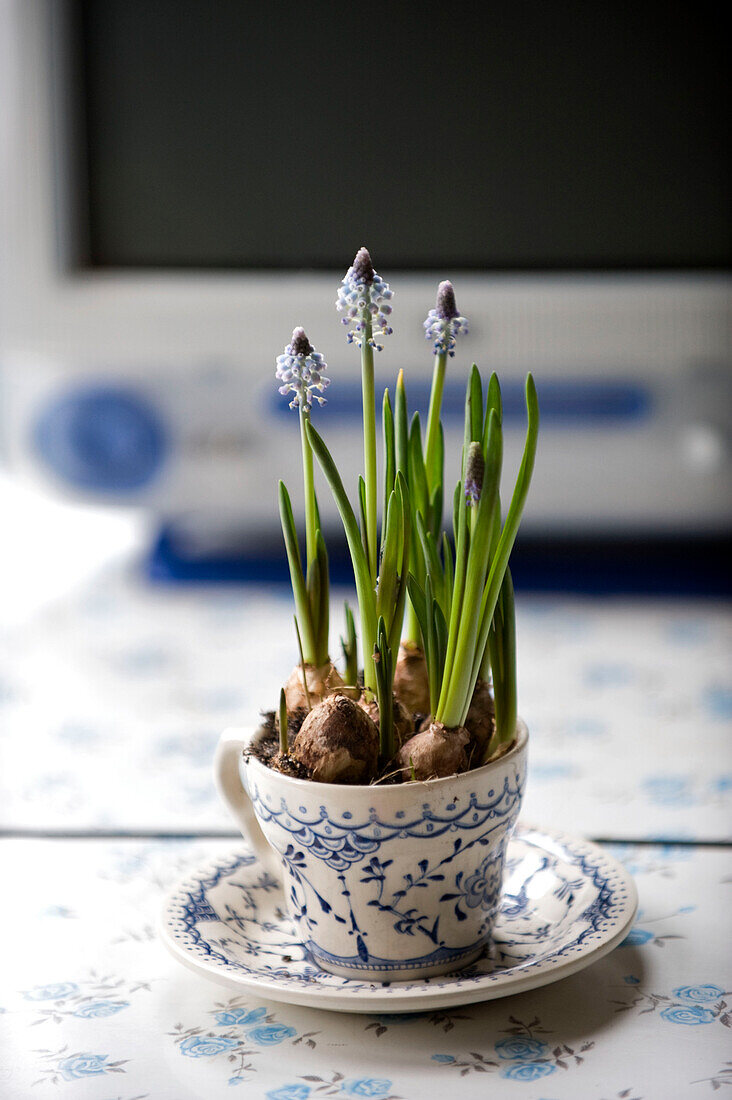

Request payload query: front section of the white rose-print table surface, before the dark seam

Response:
[0,840,732,1100]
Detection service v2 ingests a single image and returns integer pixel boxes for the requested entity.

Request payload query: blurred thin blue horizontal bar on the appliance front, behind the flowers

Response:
[271,378,653,428]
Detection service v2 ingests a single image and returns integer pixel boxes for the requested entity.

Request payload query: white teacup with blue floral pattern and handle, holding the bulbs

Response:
[215,719,528,981]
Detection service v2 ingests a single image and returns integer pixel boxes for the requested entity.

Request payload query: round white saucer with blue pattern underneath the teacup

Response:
[161,826,637,1012]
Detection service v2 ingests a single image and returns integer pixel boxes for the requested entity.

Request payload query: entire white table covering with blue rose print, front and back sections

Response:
[0,554,732,1100]
